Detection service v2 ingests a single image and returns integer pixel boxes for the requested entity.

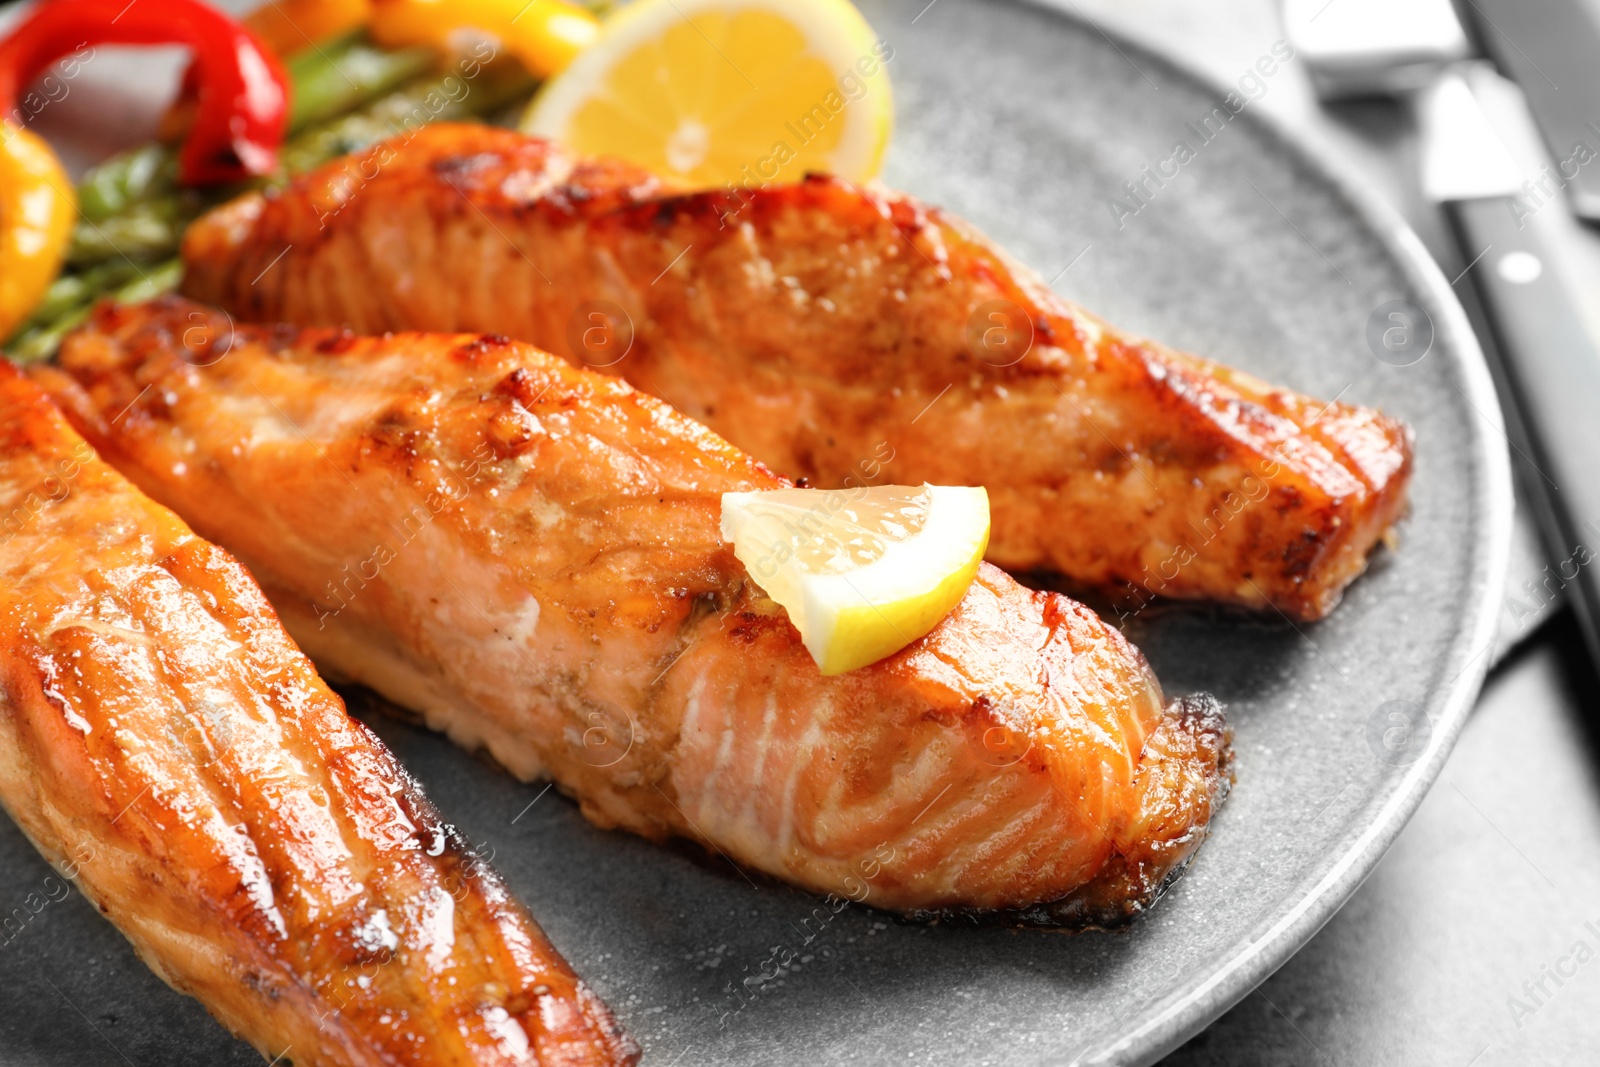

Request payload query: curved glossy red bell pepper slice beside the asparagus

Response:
[0,0,290,186]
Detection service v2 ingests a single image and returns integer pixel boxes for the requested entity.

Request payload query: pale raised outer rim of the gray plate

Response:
[984,0,1515,1067]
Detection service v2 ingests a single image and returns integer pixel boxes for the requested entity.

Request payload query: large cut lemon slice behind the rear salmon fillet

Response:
[522,0,894,187]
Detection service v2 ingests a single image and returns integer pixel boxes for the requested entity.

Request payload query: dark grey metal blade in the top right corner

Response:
[1462,0,1600,222]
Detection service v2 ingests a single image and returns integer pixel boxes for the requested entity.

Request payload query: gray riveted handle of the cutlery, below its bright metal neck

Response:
[1445,198,1600,665]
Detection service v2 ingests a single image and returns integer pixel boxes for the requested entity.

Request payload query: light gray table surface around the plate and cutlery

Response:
[1064,0,1600,1067]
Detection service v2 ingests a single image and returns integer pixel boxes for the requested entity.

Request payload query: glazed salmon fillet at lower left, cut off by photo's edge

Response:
[0,360,637,1067]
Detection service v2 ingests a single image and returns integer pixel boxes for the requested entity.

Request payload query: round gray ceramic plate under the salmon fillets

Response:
[0,0,1512,1067]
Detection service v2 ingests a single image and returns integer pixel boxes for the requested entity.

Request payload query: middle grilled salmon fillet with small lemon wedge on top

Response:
[43,301,1229,925]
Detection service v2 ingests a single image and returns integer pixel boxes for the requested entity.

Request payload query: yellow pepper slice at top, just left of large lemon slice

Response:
[371,0,600,78]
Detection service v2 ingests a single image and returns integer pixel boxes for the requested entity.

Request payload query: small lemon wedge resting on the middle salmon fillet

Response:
[722,485,989,675]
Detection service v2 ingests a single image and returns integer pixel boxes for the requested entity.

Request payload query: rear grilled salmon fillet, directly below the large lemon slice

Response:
[184,126,1411,619]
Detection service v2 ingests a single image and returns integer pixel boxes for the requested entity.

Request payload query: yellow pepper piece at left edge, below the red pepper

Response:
[0,123,78,339]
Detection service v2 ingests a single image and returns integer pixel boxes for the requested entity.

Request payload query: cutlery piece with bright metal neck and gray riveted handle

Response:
[1418,69,1600,665]
